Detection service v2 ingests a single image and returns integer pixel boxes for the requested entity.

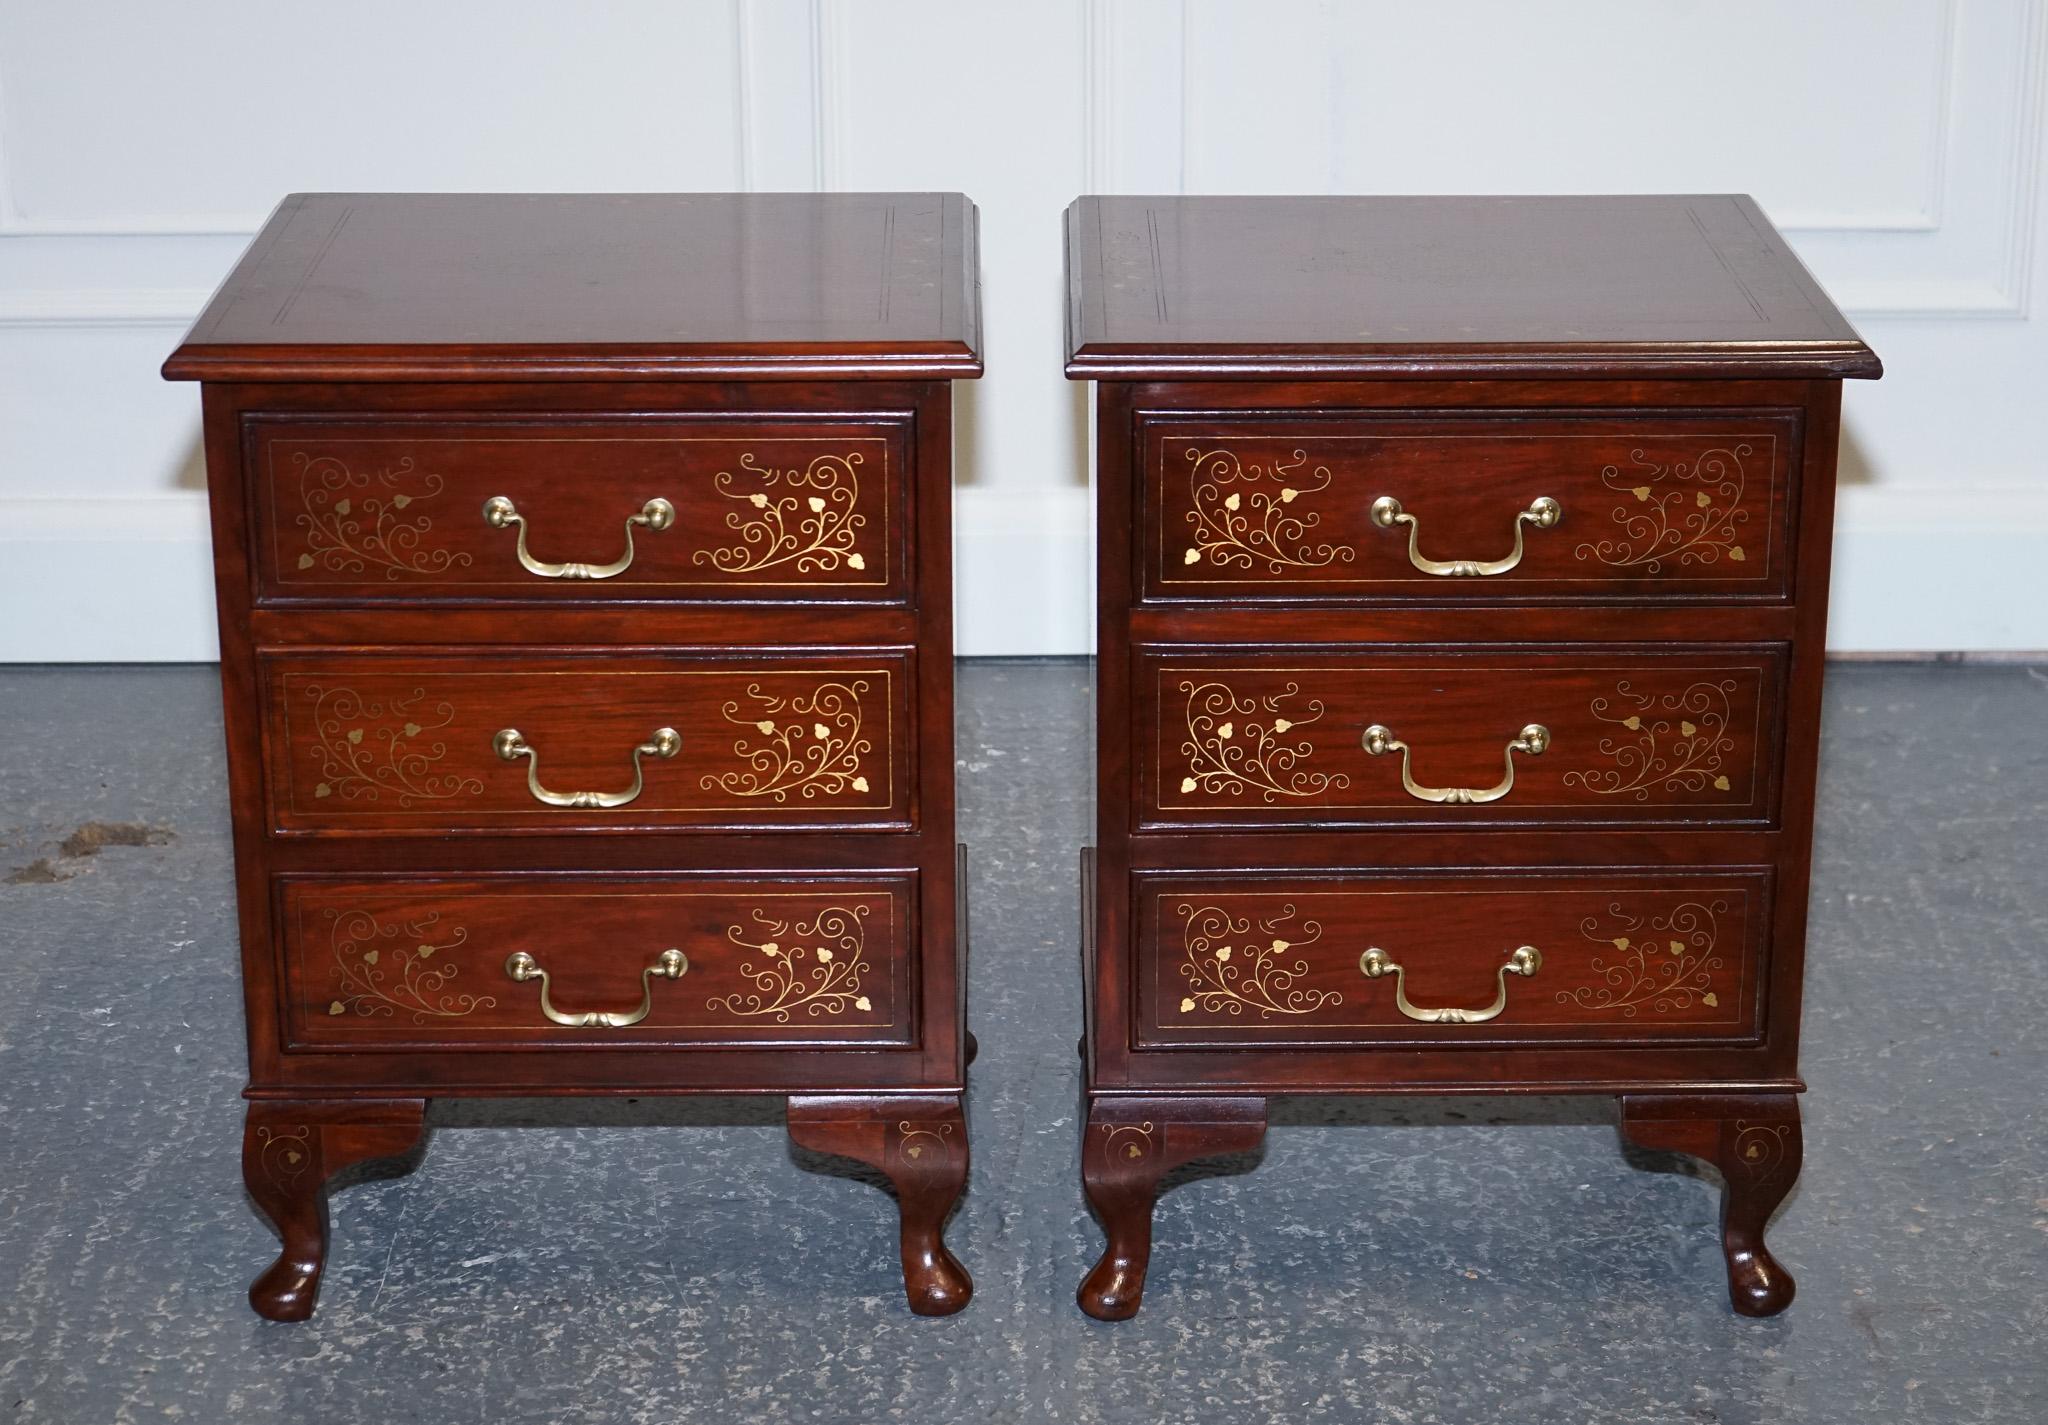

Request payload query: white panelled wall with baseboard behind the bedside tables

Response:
[0,0,2048,661]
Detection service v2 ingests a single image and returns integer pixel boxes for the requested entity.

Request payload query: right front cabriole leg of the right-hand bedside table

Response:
[1622,1093,1802,1316]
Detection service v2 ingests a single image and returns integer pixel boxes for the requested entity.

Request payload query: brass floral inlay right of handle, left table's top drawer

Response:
[692,450,868,573]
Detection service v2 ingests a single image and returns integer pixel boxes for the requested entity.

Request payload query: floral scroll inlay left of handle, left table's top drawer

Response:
[291,450,469,579]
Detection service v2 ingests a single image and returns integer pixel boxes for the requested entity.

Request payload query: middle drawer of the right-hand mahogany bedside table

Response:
[1133,647,1786,829]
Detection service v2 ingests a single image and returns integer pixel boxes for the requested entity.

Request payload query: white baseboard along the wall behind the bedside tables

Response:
[0,485,2048,663]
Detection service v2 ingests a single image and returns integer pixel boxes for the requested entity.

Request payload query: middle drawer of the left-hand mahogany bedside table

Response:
[260,649,918,835]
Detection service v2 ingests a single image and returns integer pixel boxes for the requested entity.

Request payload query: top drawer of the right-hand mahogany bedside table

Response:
[1139,409,1800,604]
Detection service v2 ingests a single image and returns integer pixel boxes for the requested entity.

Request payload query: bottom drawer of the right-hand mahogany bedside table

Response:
[1133,870,1769,1048]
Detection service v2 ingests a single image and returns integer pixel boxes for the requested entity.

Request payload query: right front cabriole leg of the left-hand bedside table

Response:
[788,1095,975,1316]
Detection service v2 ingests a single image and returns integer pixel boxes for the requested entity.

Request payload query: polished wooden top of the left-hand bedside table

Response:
[164,192,981,381]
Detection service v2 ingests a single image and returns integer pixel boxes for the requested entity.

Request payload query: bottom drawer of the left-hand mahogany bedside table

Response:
[276,874,918,1050]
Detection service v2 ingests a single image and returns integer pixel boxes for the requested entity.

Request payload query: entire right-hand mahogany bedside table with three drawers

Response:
[1067,197,1880,1319]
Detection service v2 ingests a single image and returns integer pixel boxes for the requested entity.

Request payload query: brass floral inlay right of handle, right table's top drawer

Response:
[1573,444,1751,573]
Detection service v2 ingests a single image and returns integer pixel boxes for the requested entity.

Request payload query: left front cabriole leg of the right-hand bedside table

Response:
[1079,1097,1266,1321]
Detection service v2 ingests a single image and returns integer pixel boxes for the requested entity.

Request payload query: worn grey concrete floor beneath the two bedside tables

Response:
[0,663,2048,1425]
